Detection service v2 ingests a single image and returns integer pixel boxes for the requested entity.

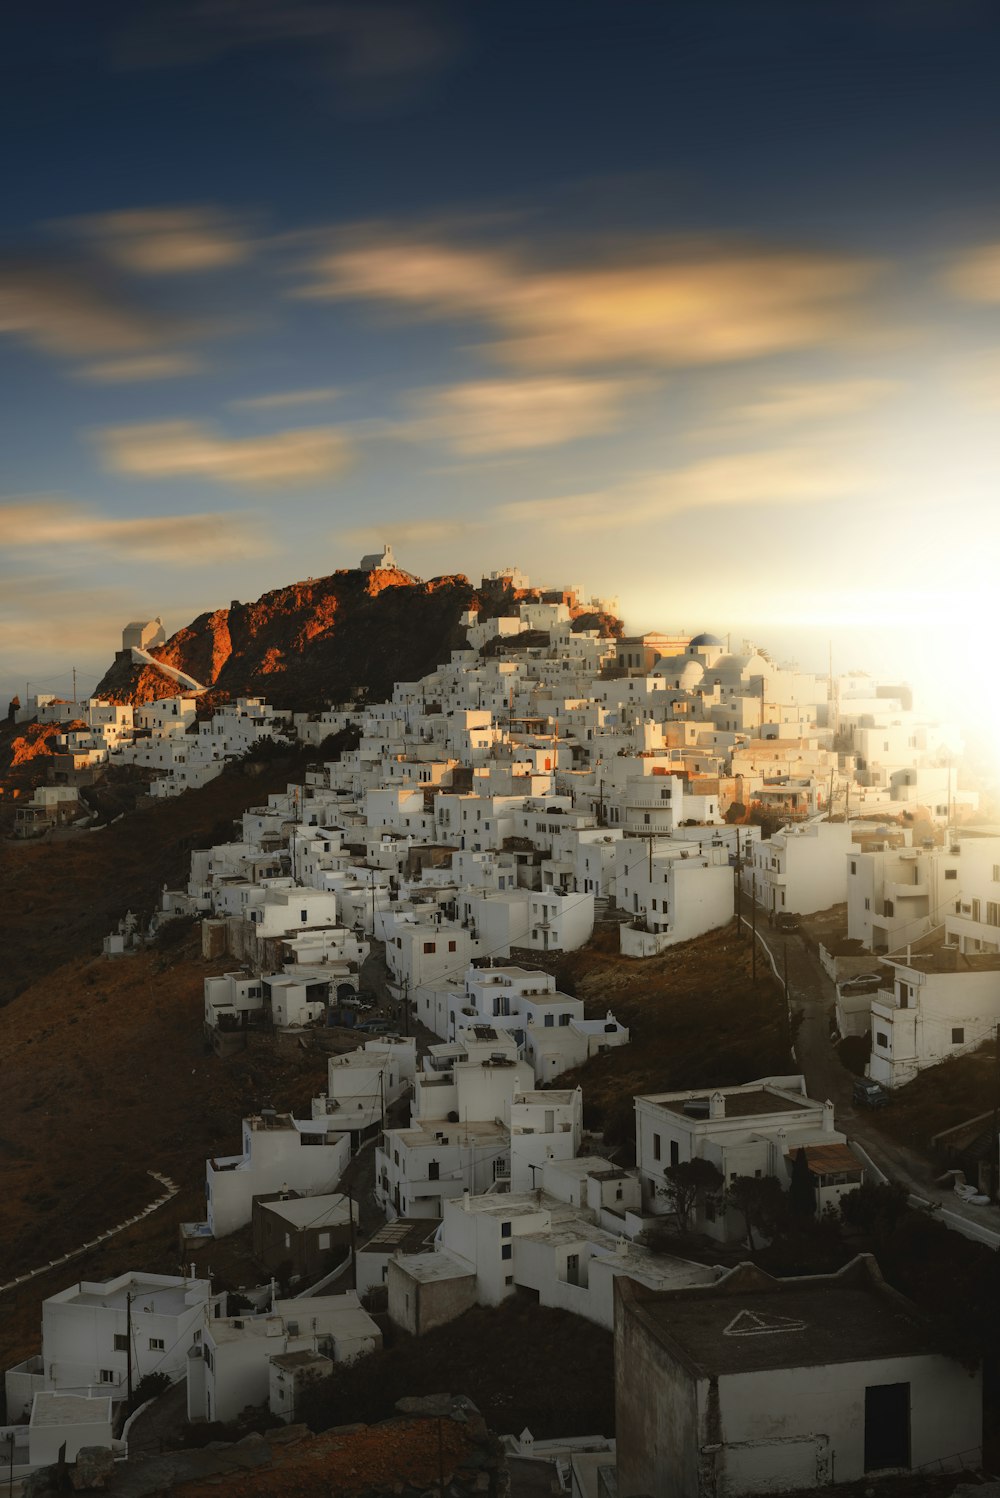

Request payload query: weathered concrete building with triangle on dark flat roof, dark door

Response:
[615,1255,982,1498]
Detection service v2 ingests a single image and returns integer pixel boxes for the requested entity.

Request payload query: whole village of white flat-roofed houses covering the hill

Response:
[0,557,1000,1498]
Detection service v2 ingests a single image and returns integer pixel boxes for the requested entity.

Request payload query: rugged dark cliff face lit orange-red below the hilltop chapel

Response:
[96,569,475,712]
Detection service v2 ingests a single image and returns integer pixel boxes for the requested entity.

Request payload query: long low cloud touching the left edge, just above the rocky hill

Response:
[0,497,269,563]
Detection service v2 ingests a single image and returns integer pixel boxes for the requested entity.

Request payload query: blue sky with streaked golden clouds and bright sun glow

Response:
[0,0,1000,749]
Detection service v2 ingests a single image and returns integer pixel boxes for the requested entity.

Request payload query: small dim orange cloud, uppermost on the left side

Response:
[70,208,250,276]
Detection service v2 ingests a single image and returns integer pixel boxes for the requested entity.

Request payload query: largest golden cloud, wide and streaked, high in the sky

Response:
[293,226,877,369]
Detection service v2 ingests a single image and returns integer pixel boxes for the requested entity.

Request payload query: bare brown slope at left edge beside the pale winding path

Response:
[0,932,325,1368]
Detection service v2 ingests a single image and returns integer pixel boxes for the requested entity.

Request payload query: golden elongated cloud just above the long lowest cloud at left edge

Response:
[97,421,353,487]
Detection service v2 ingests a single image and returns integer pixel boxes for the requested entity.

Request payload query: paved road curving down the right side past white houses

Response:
[744,896,1000,1233]
